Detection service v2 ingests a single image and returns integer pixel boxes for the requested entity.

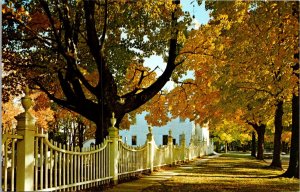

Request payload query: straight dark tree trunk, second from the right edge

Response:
[270,101,283,169]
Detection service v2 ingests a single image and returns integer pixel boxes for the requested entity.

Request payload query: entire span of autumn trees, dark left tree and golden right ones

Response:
[2,0,299,177]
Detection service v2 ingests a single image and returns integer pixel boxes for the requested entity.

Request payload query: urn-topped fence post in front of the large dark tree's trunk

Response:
[108,113,119,185]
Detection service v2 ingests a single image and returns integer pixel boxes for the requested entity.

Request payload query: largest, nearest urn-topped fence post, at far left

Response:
[15,87,36,191]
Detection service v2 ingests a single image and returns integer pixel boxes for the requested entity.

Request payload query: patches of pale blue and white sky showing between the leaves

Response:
[144,0,209,90]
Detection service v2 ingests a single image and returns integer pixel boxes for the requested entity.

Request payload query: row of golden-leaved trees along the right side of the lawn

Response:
[165,2,299,177]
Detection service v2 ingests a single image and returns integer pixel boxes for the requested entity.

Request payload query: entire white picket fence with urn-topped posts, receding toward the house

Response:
[2,90,212,191]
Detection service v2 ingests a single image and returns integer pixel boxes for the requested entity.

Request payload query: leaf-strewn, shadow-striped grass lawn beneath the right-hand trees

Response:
[143,153,300,192]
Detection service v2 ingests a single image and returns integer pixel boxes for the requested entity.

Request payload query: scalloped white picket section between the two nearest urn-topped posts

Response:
[34,134,112,191]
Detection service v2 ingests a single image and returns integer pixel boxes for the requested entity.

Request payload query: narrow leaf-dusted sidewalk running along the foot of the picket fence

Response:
[104,155,219,192]
